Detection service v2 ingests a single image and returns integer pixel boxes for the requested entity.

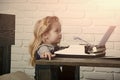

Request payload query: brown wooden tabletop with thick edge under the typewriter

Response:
[36,58,120,68]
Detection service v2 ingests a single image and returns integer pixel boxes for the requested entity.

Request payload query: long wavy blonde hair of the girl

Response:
[29,16,59,66]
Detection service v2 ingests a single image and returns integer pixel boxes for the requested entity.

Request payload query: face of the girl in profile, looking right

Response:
[47,22,62,44]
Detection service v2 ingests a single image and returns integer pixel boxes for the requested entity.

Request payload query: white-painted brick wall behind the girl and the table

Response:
[0,0,120,80]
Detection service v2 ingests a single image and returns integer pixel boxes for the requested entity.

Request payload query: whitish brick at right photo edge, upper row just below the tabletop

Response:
[95,67,120,72]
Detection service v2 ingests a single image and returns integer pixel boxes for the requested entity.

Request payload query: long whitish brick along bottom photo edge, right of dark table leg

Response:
[84,72,113,80]
